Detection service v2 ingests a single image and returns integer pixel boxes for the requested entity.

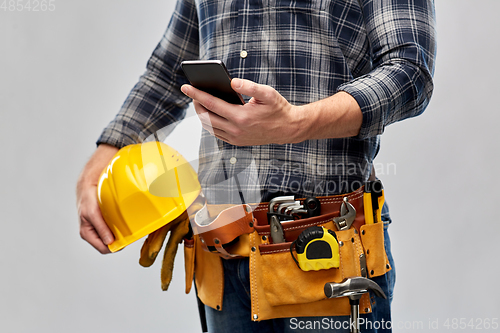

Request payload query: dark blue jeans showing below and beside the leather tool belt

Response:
[205,205,396,333]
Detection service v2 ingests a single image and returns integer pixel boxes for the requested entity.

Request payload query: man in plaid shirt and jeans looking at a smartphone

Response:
[78,0,436,332]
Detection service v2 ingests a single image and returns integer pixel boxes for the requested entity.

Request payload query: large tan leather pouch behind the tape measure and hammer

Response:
[250,205,390,321]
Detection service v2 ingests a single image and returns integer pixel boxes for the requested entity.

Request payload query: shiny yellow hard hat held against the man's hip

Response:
[97,141,201,252]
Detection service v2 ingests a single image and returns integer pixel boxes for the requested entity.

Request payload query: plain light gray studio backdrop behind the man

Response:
[0,0,500,333]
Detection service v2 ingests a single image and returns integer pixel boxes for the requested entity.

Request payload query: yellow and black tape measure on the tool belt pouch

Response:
[290,226,340,272]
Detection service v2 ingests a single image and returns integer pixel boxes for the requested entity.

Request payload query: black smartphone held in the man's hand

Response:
[181,60,245,105]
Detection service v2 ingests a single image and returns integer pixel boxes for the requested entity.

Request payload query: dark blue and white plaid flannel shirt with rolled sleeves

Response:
[98,0,436,203]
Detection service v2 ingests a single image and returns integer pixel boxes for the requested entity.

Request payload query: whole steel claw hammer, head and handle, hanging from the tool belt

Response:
[325,277,387,333]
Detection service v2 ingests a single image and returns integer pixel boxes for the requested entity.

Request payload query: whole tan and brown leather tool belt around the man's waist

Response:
[184,185,391,321]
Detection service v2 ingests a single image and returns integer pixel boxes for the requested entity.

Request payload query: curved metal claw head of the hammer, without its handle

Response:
[325,277,387,299]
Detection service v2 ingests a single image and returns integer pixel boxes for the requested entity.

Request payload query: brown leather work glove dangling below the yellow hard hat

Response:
[139,212,189,291]
